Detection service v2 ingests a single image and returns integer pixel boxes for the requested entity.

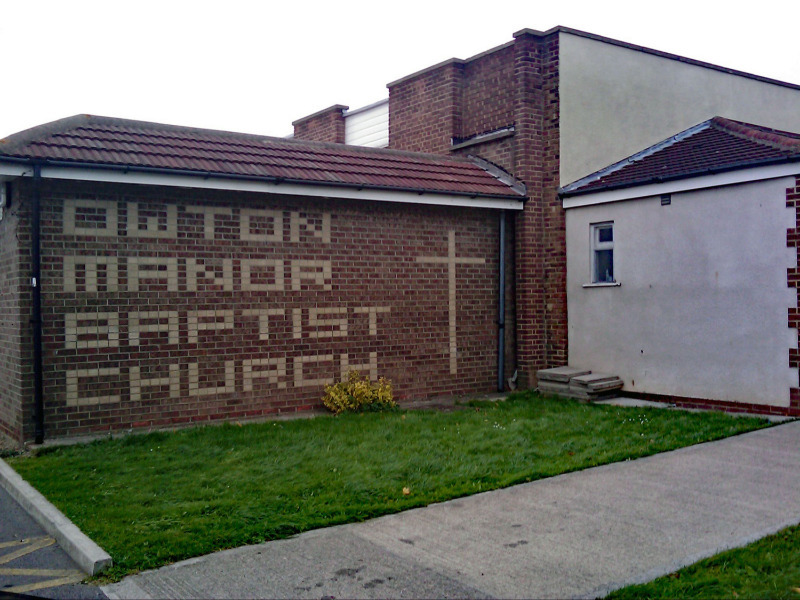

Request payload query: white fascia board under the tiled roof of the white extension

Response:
[562,162,800,209]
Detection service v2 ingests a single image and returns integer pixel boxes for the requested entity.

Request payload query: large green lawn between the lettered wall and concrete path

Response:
[3,392,768,579]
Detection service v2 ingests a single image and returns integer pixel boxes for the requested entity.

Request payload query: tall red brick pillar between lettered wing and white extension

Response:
[514,30,567,387]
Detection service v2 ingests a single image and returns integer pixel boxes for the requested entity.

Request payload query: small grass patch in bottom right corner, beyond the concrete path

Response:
[607,526,800,600]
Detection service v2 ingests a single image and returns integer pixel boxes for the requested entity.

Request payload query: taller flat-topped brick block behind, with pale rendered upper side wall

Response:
[294,27,800,386]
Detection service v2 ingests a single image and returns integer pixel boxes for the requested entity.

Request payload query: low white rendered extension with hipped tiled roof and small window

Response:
[562,118,800,414]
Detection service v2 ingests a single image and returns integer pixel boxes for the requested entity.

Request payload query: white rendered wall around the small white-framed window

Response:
[566,178,798,406]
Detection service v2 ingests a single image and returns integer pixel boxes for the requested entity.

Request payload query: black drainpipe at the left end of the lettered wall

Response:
[31,163,44,444]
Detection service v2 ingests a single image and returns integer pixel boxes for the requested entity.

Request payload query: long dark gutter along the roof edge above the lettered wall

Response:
[0,156,526,208]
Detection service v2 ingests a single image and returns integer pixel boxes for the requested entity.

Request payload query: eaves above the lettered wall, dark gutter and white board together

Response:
[0,156,526,210]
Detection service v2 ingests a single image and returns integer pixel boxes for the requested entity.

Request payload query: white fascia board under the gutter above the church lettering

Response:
[29,165,523,210]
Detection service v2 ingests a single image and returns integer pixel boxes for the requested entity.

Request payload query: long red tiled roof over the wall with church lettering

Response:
[0,115,524,200]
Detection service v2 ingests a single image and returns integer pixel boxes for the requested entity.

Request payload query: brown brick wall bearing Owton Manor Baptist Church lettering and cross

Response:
[23,182,498,437]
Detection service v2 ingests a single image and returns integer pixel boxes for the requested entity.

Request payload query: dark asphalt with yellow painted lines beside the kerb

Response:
[0,487,106,600]
